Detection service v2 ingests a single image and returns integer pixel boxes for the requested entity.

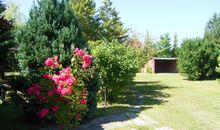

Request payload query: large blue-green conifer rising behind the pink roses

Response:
[15,0,87,82]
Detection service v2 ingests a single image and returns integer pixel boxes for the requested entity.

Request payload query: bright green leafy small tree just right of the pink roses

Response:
[92,41,139,101]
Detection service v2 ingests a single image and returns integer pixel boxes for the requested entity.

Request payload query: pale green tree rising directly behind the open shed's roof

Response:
[156,33,171,57]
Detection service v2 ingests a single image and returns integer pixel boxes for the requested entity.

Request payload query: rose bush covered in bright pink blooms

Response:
[27,48,95,127]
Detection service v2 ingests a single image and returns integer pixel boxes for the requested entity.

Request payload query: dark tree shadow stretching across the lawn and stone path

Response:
[77,81,172,130]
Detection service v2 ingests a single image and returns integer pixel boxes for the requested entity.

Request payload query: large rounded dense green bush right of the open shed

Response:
[178,38,219,80]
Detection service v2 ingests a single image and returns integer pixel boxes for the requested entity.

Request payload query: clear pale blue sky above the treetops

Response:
[5,0,220,41]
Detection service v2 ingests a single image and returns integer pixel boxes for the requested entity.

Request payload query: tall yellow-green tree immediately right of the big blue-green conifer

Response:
[70,0,99,41]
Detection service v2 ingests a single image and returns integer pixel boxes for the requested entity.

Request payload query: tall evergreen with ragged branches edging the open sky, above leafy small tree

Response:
[99,0,128,43]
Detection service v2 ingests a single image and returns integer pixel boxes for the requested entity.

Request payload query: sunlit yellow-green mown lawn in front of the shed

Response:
[122,74,220,130]
